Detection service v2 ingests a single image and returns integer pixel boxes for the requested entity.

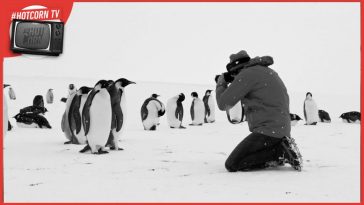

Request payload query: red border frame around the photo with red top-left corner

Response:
[0,0,364,205]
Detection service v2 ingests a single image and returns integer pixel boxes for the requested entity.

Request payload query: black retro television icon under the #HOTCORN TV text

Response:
[10,19,64,56]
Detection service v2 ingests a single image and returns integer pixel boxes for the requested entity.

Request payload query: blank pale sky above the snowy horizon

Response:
[4,3,360,95]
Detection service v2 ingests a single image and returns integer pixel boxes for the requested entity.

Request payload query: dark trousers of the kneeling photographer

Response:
[225,133,283,172]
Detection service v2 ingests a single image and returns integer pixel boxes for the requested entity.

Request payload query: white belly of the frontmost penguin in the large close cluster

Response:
[87,89,111,153]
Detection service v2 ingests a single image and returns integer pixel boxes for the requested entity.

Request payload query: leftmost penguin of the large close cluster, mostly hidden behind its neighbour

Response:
[61,84,78,144]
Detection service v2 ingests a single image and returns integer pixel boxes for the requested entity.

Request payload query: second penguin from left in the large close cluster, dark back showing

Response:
[67,86,92,144]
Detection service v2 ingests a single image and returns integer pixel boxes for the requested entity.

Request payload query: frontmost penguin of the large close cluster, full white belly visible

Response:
[81,80,112,154]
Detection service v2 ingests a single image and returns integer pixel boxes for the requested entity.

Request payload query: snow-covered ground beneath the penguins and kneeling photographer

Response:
[3,76,360,202]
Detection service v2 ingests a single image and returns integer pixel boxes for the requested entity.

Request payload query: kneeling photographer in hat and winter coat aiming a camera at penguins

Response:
[215,50,302,172]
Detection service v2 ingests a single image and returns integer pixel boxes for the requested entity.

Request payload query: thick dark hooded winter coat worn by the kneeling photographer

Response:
[216,58,291,138]
